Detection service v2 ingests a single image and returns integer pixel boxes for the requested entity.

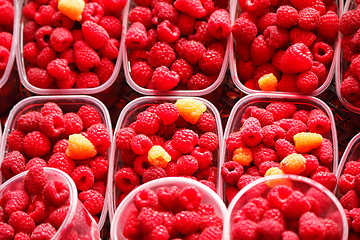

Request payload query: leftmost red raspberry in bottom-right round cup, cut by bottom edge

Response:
[231,220,258,240]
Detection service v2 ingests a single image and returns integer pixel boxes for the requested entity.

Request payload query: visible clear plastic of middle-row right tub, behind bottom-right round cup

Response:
[221,93,338,199]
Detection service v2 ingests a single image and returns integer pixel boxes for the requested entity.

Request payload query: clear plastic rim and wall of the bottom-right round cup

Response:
[223,174,348,240]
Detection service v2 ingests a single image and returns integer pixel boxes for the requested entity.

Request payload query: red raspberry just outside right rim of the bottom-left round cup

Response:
[79,190,104,215]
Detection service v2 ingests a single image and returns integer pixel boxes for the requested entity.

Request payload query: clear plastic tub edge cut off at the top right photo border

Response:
[335,0,360,114]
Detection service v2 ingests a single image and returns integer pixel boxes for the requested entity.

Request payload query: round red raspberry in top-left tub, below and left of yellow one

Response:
[50,27,73,52]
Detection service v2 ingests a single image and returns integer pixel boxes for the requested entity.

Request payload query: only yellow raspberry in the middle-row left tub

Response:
[66,134,97,160]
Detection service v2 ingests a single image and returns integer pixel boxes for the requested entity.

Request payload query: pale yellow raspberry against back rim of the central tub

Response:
[175,98,206,124]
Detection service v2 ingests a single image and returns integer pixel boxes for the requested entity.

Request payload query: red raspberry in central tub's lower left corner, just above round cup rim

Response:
[115,168,140,193]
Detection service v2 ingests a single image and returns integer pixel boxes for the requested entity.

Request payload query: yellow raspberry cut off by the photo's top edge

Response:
[58,0,85,21]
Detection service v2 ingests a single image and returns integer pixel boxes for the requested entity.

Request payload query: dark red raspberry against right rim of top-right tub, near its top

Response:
[317,11,340,39]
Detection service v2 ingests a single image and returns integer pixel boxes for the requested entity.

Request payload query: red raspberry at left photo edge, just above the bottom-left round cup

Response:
[1,150,25,179]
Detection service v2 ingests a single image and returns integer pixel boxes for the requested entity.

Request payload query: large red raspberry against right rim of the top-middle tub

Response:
[208,9,231,39]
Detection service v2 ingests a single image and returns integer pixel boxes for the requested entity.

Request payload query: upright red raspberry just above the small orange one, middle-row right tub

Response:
[240,117,263,147]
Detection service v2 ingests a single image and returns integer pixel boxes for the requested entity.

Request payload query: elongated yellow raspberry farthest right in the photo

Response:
[294,132,323,153]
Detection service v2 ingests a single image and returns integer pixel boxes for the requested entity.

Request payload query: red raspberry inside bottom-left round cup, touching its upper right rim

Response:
[43,180,70,207]
